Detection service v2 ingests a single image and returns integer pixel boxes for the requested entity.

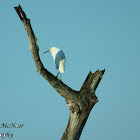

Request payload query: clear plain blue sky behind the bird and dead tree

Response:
[0,0,140,140]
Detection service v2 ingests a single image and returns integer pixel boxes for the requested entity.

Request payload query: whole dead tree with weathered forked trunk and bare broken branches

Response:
[14,5,105,140]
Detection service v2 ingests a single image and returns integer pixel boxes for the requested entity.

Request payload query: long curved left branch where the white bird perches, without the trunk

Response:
[14,5,76,98]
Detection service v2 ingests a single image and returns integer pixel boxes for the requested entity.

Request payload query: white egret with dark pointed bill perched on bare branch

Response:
[43,47,66,80]
